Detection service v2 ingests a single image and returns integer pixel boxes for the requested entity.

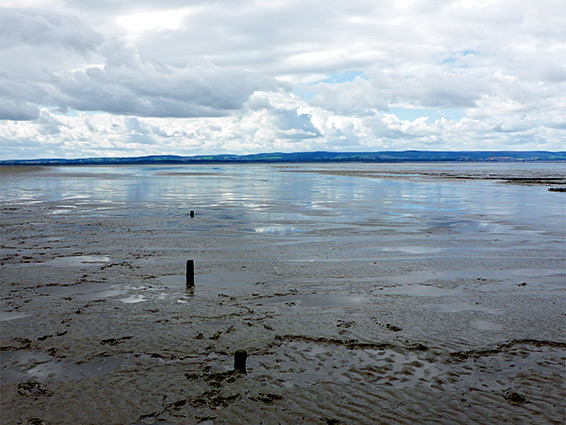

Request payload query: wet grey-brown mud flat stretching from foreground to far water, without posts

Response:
[0,164,566,424]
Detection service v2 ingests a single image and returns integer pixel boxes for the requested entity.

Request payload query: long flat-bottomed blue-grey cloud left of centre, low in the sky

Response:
[57,58,278,118]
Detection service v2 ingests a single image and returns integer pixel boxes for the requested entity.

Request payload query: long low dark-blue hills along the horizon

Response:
[0,150,566,165]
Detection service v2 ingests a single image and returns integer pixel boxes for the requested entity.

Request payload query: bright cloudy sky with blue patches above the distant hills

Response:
[0,0,566,159]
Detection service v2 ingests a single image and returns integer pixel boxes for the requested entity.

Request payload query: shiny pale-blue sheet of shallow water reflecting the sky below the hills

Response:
[0,164,564,235]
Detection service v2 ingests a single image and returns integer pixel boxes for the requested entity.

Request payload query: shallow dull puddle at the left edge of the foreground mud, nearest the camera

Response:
[1,351,127,382]
